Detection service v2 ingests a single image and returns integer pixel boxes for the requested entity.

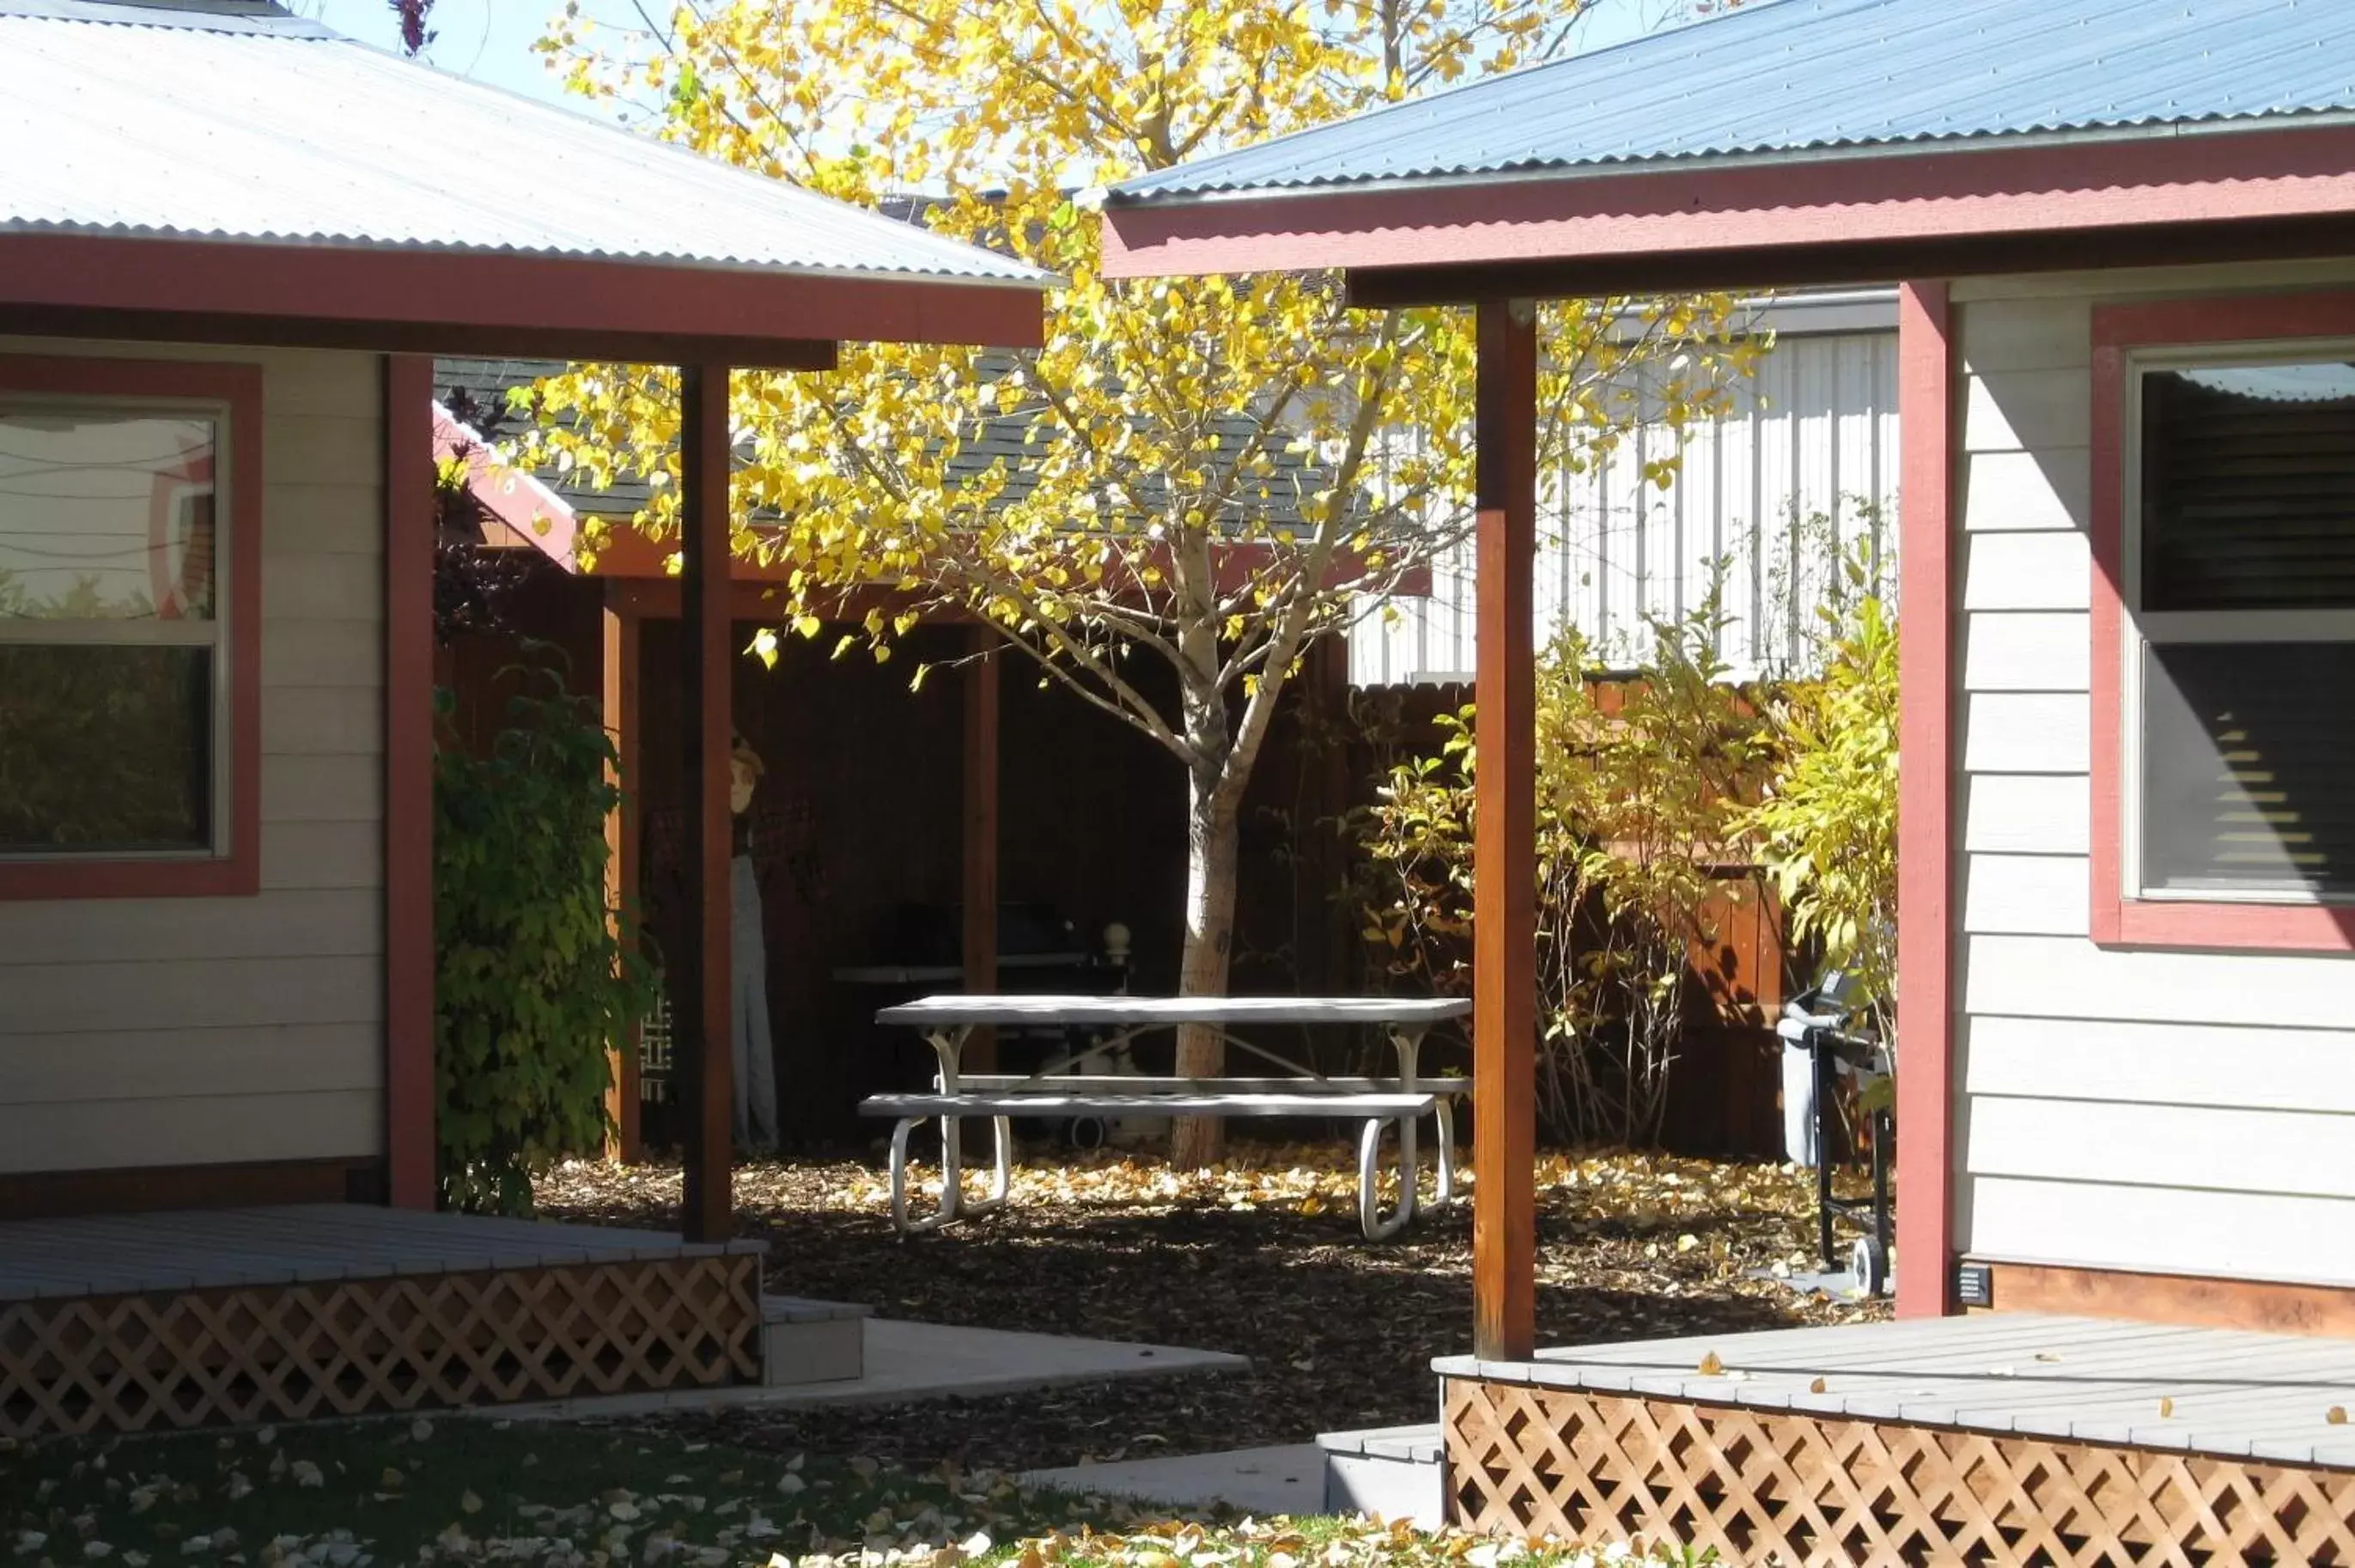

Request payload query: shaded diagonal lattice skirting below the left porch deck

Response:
[0,1253,761,1436]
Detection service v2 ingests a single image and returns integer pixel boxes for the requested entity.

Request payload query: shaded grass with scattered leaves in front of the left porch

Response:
[0,1418,1114,1568]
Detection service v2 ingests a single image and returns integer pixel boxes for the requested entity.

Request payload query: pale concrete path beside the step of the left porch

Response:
[488,1318,1243,1413]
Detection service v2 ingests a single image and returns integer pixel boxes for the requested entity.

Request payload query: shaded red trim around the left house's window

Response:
[0,356,261,899]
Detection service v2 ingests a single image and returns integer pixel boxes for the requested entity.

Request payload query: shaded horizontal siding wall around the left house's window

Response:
[0,339,384,1172]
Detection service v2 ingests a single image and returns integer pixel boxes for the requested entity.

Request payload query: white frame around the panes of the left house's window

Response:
[0,391,242,866]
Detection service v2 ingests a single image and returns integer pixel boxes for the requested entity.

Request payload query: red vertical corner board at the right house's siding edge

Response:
[1898,283,1957,1318]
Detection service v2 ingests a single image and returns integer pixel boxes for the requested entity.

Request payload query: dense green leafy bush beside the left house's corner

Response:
[434,669,653,1215]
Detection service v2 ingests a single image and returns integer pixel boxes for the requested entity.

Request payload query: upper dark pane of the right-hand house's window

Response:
[2140,360,2355,610]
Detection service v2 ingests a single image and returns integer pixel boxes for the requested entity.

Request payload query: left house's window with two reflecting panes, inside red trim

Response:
[0,403,226,857]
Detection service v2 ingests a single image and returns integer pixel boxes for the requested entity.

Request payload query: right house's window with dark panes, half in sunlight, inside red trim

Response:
[2129,356,2355,899]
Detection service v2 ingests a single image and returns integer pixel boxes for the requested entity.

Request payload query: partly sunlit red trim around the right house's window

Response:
[2089,295,2355,953]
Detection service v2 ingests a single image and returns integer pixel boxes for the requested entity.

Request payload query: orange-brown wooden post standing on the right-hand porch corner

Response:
[1472,299,1538,1361]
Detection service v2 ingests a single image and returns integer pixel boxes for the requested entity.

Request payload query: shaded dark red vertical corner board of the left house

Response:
[384,353,438,1208]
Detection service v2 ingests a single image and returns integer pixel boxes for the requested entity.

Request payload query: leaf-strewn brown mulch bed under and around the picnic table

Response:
[539,1146,1886,1469]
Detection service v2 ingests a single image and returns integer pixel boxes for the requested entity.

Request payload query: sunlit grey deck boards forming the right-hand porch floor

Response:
[1434,1311,2355,1467]
